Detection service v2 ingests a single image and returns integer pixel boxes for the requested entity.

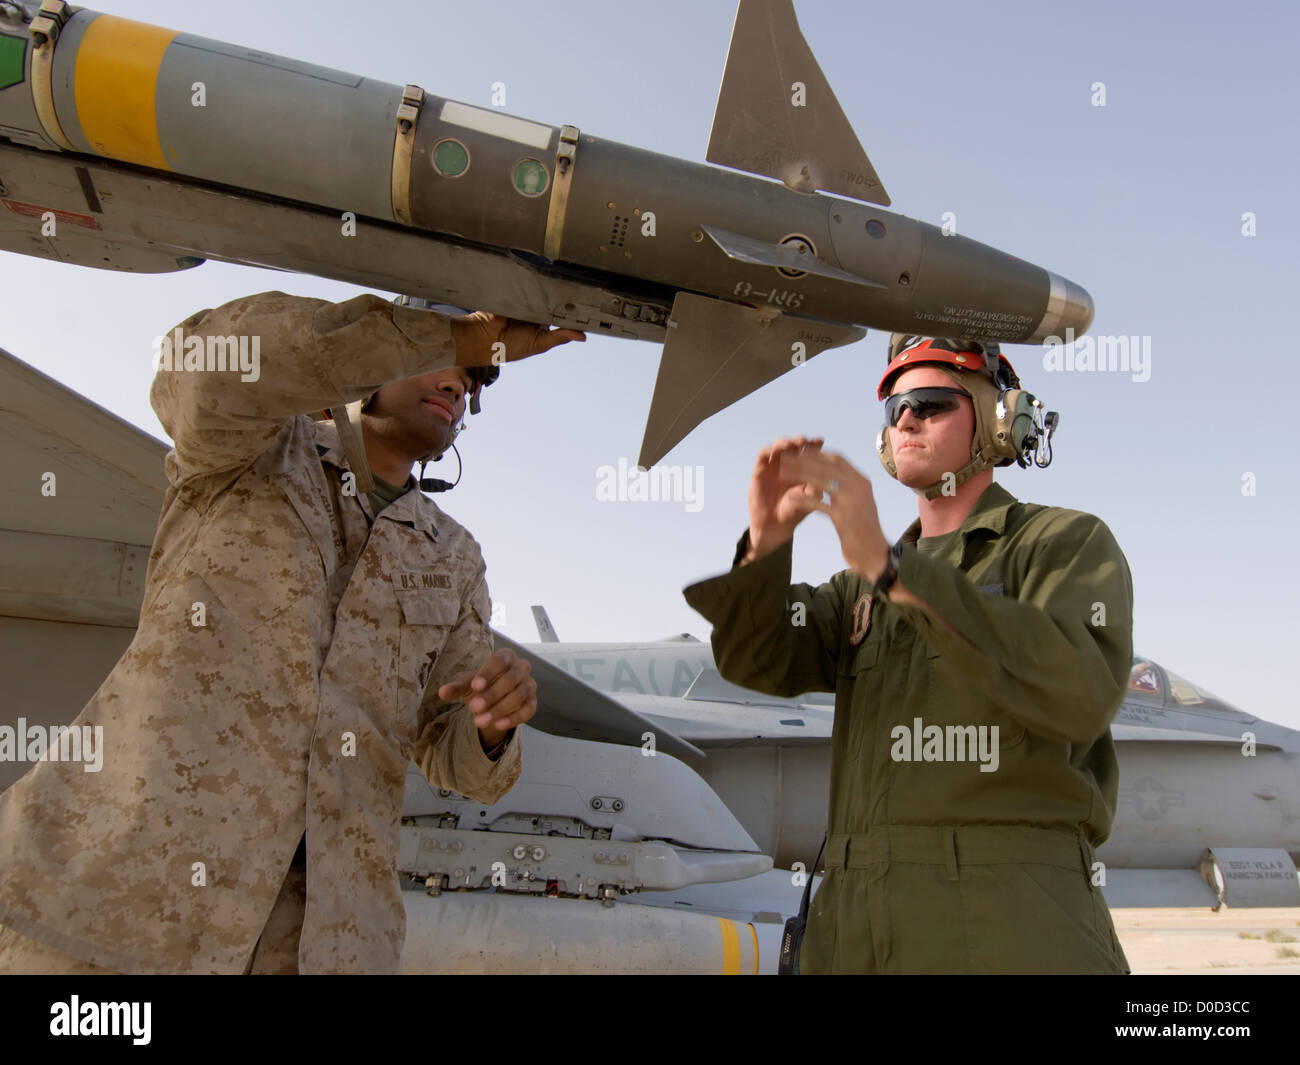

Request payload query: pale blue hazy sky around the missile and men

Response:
[0,0,1300,728]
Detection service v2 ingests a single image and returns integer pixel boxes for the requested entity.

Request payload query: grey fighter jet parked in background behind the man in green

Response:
[502,607,1300,906]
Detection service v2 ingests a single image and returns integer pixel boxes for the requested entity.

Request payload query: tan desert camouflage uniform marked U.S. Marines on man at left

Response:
[0,293,520,973]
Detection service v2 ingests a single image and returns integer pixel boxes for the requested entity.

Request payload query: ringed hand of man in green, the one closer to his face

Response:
[780,445,889,583]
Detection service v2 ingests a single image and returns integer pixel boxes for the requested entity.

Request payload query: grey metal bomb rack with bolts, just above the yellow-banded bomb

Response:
[398,824,772,899]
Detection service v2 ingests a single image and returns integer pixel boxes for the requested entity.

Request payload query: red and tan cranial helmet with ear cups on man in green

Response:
[876,333,1060,499]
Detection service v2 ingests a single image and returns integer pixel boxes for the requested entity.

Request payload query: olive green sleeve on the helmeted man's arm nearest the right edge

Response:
[896,511,1132,744]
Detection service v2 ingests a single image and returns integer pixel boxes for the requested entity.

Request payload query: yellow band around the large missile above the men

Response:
[74,14,177,170]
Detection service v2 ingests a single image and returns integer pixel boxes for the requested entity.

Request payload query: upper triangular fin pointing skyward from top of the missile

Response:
[705,0,889,207]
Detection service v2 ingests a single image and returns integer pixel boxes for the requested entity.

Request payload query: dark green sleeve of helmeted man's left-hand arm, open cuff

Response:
[683,534,844,696]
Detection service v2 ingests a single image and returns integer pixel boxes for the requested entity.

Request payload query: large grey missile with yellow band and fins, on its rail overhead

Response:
[0,0,1093,467]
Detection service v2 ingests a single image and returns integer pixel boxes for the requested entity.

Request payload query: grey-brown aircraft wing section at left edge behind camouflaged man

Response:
[0,350,168,789]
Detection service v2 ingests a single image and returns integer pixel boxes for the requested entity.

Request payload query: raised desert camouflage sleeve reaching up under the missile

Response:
[150,293,456,477]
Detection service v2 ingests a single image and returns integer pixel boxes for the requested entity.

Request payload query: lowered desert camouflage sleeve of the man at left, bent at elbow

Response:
[411,559,521,802]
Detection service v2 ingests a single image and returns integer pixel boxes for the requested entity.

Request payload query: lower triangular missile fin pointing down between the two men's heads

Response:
[637,293,867,469]
